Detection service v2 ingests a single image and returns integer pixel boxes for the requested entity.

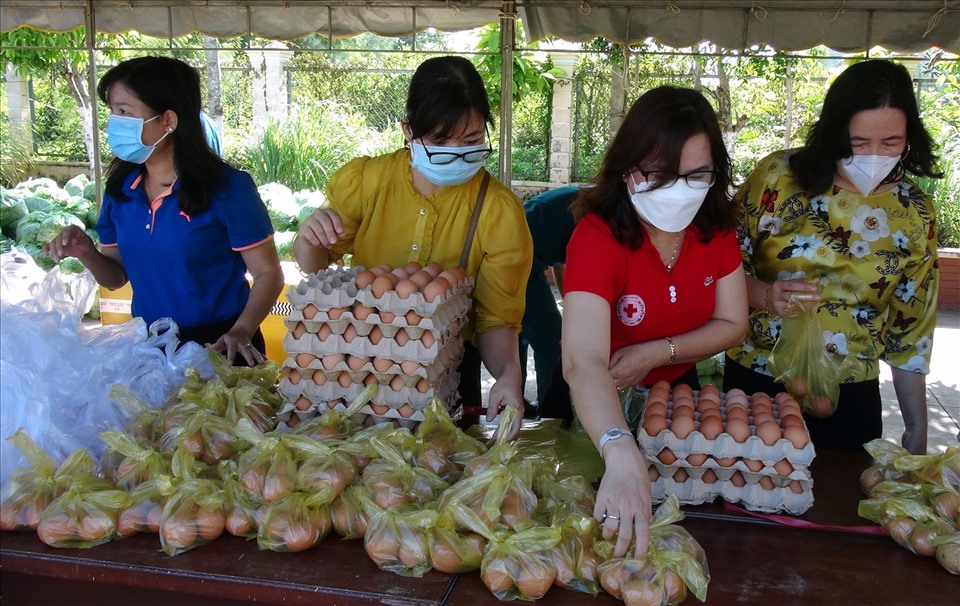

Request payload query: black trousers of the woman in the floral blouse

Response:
[723,356,883,451]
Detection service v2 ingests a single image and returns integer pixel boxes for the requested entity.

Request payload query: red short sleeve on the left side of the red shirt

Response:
[563,215,626,305]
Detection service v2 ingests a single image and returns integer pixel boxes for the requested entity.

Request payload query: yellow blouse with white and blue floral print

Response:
[727,151,939,382]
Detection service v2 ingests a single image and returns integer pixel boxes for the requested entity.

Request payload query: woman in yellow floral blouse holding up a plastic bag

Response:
[723,60,942,454]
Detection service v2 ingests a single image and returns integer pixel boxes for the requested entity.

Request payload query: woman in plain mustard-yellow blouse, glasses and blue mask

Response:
[293,57,533,436]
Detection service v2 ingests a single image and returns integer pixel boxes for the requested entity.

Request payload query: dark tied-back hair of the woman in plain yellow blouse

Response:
[407,56,493,141]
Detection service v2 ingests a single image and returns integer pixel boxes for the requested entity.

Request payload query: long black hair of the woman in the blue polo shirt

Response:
[97,57,227,215]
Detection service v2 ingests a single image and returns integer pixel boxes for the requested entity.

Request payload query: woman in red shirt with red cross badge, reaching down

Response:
[563,86,747,556]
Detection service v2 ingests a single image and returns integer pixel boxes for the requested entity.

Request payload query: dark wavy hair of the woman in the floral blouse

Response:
[790,59,943,196]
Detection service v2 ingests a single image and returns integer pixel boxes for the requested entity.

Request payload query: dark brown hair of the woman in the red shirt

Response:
[572,86,737,250]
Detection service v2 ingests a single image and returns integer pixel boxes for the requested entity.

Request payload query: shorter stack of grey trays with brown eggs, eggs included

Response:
[637,383,815,513]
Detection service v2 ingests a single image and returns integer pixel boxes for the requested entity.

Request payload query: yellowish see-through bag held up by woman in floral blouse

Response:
[769,294,852,419]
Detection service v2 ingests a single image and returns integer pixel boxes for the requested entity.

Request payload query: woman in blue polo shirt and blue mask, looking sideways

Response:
[46,57,283,364]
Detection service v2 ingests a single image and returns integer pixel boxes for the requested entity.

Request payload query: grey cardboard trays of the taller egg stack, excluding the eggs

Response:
[280,268,473,424]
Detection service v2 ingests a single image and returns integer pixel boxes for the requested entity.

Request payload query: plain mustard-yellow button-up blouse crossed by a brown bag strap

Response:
[327,149,533,339]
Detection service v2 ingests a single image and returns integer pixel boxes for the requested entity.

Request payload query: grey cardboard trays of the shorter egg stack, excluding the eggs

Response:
[637,393,816,515]
